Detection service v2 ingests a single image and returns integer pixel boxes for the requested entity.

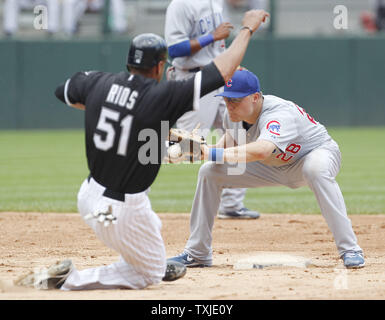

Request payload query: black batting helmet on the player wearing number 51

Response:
[127,33,167,69]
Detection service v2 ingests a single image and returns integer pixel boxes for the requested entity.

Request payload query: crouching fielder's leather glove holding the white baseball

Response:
[167,127,206,163]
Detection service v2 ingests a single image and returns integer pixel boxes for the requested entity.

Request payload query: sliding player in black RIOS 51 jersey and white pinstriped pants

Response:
[17,10,268,290]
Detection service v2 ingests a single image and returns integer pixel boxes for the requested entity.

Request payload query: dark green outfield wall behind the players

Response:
[0,37,385,129]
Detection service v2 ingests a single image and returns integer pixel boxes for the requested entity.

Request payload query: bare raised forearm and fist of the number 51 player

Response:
[214,10,270,82]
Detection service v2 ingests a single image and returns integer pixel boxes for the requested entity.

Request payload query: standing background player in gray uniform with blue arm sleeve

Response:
[165,0,259,219]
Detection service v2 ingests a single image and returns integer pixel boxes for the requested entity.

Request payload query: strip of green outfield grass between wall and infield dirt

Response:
[0,128,385,214]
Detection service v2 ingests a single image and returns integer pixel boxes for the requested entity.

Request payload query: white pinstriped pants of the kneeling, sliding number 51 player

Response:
[61,178,166,290]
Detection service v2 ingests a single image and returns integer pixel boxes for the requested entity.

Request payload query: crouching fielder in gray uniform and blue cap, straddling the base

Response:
[170,70,365,268]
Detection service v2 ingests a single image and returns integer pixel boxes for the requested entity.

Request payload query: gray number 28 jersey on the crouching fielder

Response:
[224,95,331,167]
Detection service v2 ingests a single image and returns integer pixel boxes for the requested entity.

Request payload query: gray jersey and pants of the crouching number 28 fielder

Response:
[184,95,362,265]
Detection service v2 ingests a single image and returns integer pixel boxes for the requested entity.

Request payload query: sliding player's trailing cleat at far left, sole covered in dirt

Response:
[14,260,73,290]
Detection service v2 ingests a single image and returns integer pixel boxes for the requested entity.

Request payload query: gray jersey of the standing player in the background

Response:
[165,0,225,69]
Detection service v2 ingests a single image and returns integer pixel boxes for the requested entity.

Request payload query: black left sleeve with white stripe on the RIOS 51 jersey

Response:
[55,71,101,104]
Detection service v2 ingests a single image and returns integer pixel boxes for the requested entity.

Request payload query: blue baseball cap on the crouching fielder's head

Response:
[216,70,261,98]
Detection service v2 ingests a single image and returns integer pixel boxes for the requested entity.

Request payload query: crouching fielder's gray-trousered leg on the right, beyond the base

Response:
[302,141,362,255]
